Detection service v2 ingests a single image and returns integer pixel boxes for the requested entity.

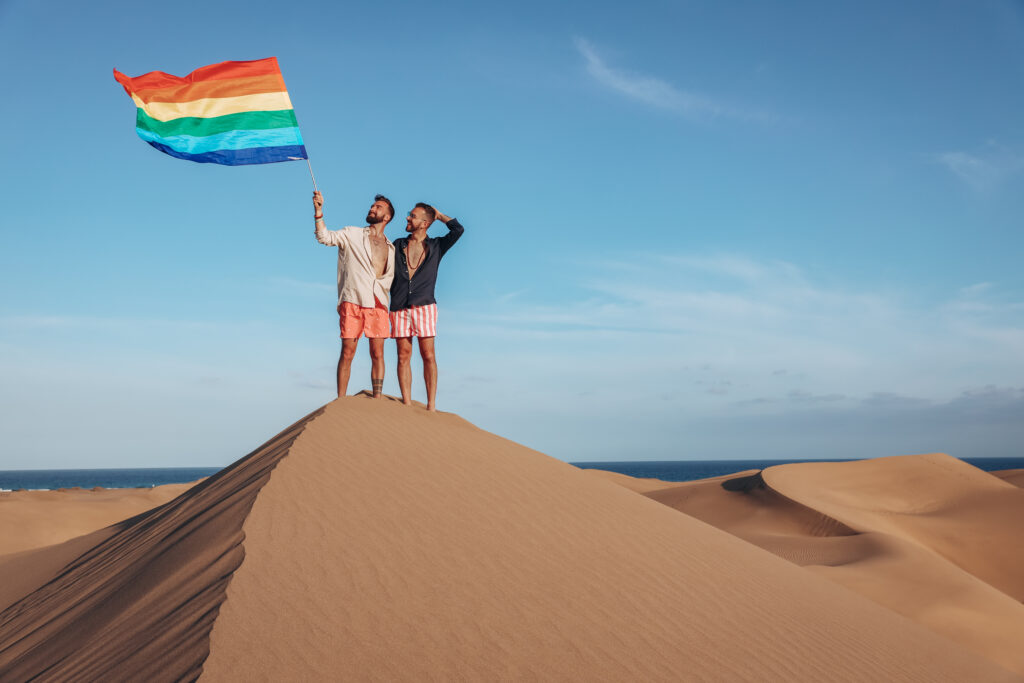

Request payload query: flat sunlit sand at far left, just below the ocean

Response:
[0,483,193,555]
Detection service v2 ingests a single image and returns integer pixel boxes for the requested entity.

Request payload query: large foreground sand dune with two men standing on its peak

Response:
[0,396,1017,681]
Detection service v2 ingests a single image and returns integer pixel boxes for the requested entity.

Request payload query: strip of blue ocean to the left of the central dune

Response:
[0,467,221,490]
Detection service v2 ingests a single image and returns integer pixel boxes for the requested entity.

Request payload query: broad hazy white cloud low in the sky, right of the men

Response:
[459,254,1024,414]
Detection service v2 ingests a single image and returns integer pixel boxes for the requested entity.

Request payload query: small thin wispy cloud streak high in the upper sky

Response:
[573,37,772,120]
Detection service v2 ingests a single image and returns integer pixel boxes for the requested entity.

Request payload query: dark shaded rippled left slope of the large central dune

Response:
[0,413,318,681]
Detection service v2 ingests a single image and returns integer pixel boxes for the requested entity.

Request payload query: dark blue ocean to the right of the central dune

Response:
[572,458,1024,481]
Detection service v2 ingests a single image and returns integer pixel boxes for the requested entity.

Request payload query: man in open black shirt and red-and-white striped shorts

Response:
[390,202,463,412]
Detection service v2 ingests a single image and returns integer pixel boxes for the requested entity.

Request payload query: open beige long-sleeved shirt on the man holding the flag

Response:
[316,222,394,308]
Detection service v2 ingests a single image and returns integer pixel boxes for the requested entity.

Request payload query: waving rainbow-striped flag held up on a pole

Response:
[114,57,307,166]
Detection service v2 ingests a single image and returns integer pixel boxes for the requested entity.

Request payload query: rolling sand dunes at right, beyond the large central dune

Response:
[598,455,1024,673]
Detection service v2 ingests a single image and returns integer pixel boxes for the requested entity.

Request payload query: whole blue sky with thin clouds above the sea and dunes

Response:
[0,0,1024,469]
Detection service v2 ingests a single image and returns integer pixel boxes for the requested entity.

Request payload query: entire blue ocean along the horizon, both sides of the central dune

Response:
[0,458,1024,490]
